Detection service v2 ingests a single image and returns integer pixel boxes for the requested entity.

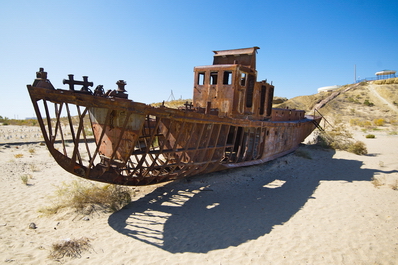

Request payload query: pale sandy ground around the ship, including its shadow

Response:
[0,126,398,265]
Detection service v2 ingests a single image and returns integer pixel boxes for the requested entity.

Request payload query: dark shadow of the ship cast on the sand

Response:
[108,148,397,253]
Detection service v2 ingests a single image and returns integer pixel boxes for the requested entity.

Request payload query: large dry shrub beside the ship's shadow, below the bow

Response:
[39,181,131,214]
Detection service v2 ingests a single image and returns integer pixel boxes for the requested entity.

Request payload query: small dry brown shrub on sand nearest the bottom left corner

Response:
[49,237,91,260]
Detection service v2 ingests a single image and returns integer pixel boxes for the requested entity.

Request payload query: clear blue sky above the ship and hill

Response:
[0,0,398,119]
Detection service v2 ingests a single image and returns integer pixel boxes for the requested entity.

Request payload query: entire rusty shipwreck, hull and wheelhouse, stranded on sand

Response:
[27,47,321,185]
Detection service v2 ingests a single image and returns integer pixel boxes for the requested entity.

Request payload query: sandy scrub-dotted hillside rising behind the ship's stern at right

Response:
[274,78,398,127]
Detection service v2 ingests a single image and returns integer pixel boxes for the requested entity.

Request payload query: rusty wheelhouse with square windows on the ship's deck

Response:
[193,47,274,120]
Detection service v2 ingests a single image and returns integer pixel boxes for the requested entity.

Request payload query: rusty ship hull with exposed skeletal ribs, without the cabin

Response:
[28,85,320,186]
